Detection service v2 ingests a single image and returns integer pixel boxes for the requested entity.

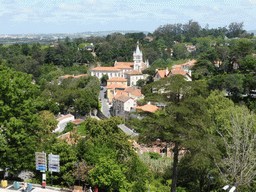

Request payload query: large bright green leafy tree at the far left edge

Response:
[0,66,43,172]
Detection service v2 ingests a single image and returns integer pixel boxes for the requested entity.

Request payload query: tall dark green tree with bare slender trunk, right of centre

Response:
[131,75,209,192]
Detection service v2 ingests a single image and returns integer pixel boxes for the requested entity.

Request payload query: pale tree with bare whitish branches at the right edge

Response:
[216,106,256,187]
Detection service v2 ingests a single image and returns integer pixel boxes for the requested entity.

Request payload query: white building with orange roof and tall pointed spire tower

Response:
[91,43,149,86]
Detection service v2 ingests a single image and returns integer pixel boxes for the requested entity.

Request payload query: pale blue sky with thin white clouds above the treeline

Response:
[0,0,256,34]
